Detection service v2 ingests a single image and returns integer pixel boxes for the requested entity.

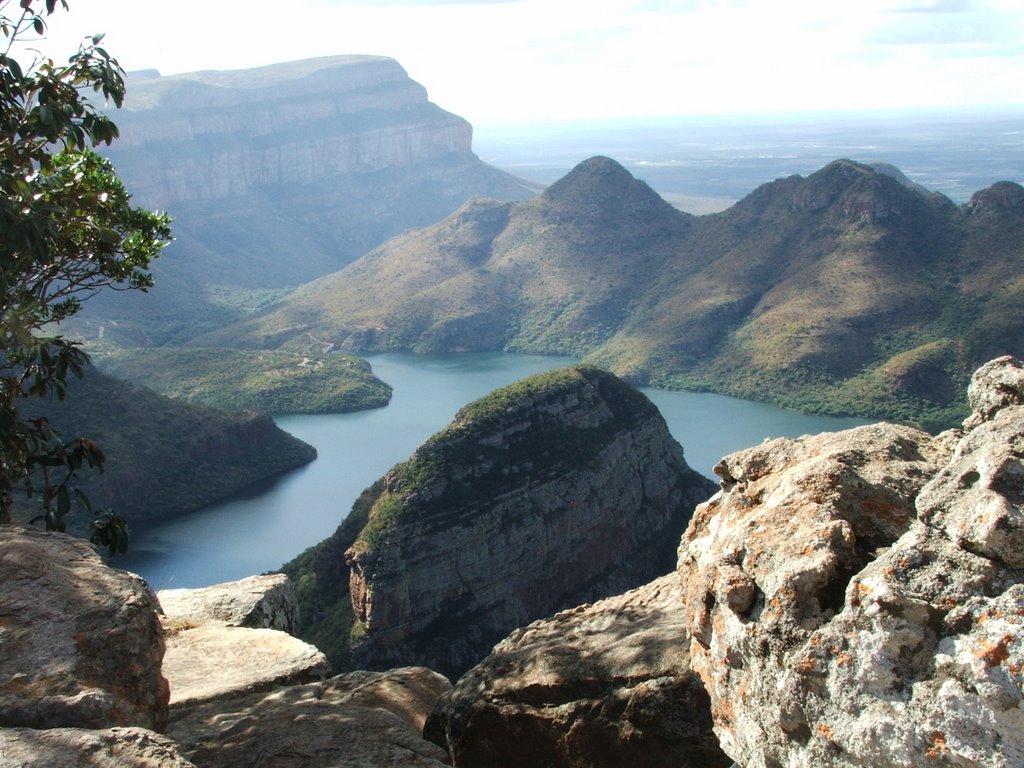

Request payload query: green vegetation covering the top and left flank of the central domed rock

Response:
[282,366,657,669]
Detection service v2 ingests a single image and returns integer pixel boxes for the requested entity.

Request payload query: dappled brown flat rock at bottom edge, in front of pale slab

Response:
[168,668,452,768]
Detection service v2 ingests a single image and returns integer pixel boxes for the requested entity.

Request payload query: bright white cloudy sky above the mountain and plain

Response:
[19,0,1024,128]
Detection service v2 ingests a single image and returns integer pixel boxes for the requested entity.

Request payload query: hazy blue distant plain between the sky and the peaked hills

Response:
[473,110,1024,214]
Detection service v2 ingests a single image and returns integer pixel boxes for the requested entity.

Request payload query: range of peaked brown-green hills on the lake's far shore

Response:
[201,157,1024,429]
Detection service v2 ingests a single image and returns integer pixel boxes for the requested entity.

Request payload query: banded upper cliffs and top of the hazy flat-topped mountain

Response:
[111,56,473,209]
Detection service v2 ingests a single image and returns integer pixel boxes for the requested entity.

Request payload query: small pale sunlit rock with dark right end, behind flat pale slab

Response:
[157,573,299,635]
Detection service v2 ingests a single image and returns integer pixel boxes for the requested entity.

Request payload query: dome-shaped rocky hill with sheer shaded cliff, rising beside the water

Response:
[345,367,714,677]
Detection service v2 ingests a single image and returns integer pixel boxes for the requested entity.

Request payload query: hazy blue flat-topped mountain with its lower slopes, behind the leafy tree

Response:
[83,55,540,345]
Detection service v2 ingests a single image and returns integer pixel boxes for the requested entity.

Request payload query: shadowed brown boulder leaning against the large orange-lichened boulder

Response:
[426,573,732,768]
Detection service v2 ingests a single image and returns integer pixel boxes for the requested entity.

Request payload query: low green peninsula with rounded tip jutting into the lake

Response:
[95,347,391,414]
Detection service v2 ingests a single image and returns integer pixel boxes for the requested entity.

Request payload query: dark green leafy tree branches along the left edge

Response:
[0,0,170,552]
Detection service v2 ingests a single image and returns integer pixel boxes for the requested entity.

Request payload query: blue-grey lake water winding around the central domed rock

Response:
[112,353,865,590]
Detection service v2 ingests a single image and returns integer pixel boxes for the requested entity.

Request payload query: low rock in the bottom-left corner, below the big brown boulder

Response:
[0,728,195,768]
